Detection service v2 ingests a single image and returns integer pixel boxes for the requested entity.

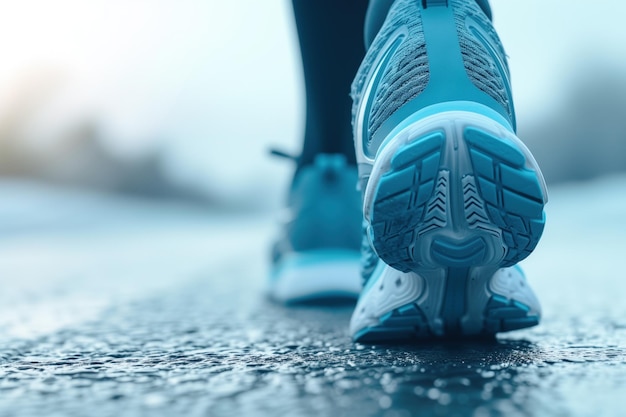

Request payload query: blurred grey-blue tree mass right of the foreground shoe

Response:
[520,62,626,183]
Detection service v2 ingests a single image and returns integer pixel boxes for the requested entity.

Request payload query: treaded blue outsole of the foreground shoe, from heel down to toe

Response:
[355,111,547,340]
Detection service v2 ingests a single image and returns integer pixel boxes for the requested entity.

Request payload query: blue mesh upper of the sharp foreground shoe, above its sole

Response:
[351,0,515,174]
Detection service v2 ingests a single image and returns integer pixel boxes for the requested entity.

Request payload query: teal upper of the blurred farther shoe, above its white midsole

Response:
[273,154,363,262]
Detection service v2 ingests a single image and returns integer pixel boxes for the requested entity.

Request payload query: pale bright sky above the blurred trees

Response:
[0,0,626,204]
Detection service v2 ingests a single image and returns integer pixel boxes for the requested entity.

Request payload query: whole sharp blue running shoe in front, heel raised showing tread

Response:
[351,0,547,342]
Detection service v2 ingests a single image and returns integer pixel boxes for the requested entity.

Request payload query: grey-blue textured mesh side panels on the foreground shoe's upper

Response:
[351,0,513,138]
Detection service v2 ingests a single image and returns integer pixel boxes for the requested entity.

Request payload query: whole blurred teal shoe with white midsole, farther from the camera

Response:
[269,154,363,303]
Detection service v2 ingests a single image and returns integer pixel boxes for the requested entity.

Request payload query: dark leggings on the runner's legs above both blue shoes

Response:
[292,0,491,167]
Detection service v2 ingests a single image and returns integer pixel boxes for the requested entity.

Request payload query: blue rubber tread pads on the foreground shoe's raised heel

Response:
[370,127,545,272]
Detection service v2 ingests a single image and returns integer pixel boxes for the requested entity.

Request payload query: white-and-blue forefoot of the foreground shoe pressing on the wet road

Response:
[351,267,540,343]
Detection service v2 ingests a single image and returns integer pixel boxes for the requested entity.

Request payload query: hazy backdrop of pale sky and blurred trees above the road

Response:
[0,0,626,209]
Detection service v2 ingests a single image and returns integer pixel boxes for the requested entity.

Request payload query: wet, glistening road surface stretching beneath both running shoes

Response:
[0,178,626,417]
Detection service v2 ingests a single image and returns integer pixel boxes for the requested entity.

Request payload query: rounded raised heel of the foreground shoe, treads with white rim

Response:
[365,111,546,272]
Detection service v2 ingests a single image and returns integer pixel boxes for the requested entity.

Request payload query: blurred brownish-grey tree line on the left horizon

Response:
[0,71,216,204]
